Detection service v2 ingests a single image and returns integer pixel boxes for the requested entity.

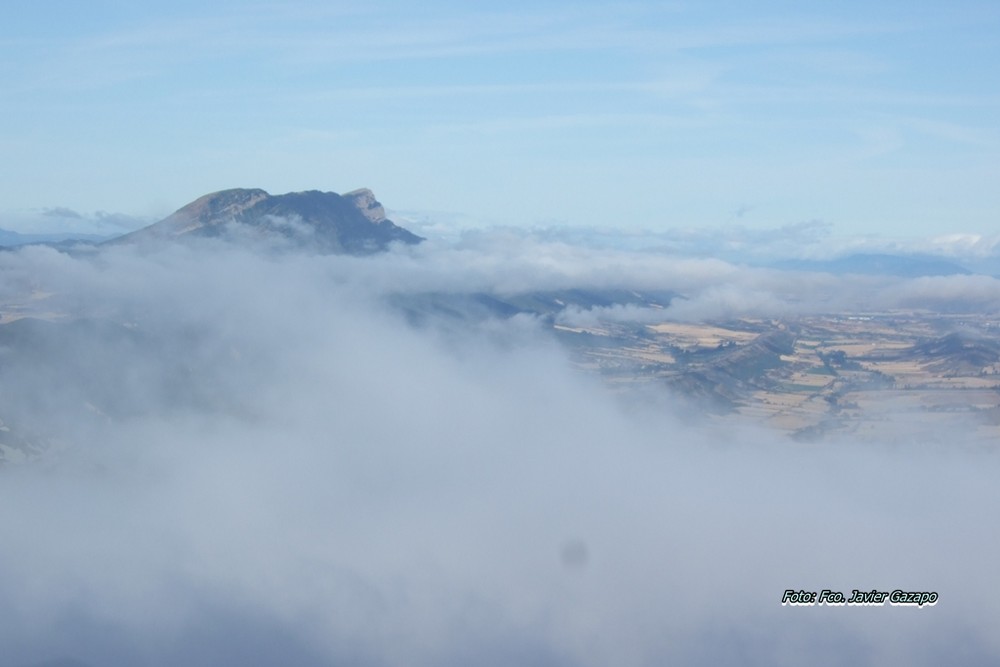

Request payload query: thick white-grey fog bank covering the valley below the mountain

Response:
[0,241,1000,667]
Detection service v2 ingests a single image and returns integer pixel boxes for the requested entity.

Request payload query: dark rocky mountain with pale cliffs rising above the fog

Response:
[109,189,423,255]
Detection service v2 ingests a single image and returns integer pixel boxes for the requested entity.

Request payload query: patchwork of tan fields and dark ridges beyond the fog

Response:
[556,311,1000,442]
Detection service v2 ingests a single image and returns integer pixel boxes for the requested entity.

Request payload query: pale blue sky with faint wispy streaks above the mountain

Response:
[0,0,1000,236]
